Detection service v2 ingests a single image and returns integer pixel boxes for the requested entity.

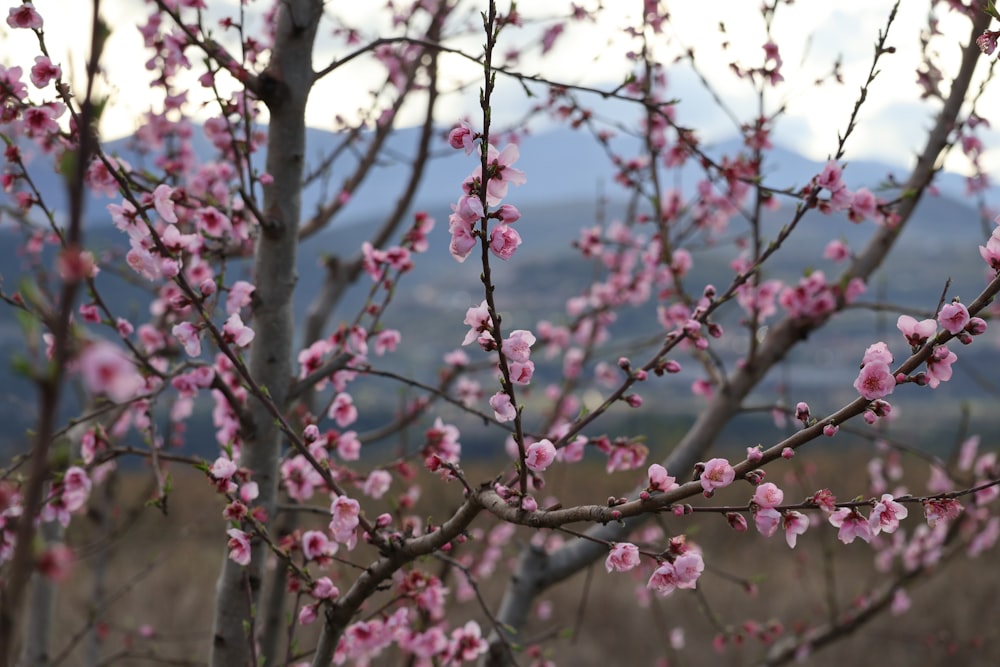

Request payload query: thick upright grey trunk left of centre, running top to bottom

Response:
[211,5,323,667]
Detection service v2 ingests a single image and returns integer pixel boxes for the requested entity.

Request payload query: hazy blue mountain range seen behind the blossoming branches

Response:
[0,125,992,460]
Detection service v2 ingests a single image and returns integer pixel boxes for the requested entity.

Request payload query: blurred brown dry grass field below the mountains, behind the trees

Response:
[31,452,1000,667]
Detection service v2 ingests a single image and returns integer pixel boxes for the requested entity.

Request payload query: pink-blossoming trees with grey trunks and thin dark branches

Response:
[0,0,1000,665]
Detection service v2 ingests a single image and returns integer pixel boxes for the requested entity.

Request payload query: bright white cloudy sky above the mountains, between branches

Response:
[0,0,1000,180]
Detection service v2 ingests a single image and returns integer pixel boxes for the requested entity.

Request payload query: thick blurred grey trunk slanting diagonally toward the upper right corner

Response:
[483,13,989,666]
